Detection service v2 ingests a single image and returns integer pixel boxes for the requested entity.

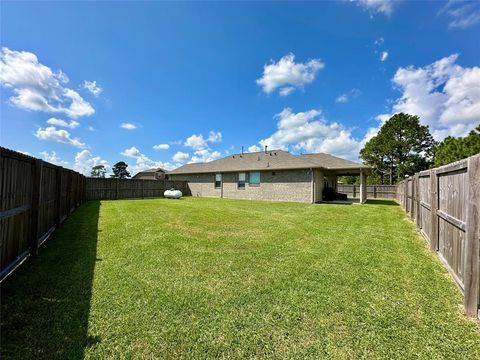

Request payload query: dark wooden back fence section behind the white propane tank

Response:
[86,178,189,200]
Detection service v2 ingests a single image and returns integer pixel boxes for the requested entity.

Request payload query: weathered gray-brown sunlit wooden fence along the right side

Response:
[397,155,480,316]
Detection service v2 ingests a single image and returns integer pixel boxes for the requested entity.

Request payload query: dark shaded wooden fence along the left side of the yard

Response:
[0,148,85,281]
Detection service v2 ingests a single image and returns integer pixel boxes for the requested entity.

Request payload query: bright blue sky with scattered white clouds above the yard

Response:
[0,0,480,173]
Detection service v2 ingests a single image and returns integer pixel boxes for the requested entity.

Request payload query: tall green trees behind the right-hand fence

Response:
[341,113,480,184]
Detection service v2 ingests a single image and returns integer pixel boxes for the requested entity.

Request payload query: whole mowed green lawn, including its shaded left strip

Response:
[1,198,480,359]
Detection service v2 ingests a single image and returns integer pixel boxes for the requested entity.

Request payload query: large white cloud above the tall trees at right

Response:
[377,54,480,140]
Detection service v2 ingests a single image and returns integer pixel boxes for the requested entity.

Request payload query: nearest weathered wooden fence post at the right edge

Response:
[464,155,480,316]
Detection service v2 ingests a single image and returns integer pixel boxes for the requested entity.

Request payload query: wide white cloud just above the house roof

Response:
[259,108,371,160]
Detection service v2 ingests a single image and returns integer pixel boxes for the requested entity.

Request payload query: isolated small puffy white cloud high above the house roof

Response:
[257,53,325,96]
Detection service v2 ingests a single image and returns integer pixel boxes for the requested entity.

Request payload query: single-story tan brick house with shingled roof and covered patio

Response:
[168,149,368,203]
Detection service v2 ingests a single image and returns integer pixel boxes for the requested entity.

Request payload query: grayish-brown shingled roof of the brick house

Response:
[168,150,368,174]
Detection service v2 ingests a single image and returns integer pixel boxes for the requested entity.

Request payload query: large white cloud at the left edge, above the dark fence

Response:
[0,47,95,118]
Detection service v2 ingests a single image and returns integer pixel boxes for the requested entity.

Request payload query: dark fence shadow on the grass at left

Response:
[0,201,101,359]
